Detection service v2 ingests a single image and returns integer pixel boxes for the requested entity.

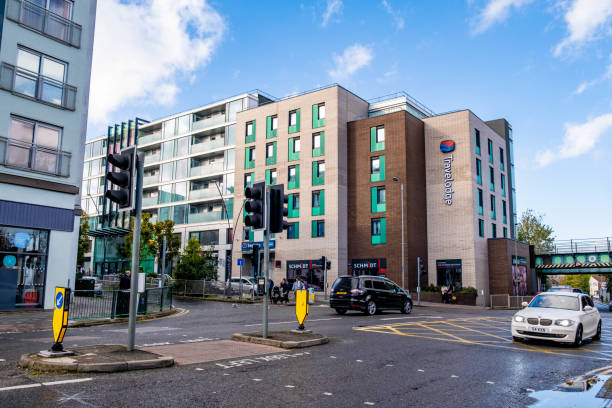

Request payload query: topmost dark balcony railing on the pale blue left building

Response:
[6,0,83,48]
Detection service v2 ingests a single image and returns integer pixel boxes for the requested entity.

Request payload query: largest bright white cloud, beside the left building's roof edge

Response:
[89,0,225,123]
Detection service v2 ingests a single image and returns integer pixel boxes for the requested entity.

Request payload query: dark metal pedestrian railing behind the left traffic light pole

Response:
[68,287,172,320]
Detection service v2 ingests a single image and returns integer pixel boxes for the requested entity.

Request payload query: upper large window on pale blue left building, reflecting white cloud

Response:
[13,48,68,110]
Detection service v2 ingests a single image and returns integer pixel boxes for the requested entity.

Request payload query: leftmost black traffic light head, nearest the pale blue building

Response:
[104,146,137,211]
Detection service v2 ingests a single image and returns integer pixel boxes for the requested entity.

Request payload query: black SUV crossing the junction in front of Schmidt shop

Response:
[329,275,412,315]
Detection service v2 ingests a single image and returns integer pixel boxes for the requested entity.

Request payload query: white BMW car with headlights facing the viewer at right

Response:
[512,292,601,346]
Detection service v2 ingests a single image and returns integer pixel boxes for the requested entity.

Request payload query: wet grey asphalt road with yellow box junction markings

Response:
[0,301,612,407]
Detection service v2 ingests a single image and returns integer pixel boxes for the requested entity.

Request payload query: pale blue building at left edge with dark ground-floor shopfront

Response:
[0,0,96,309]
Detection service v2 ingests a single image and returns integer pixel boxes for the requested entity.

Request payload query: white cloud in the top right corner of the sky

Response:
[554,0,612,56]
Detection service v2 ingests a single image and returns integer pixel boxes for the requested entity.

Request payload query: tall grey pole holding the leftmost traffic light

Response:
[127,153,144,351]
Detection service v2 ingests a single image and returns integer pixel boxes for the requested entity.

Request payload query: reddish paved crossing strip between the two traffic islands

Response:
[141,340,284,364]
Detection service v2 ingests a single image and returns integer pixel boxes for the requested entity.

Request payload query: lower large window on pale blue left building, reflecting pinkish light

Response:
[6,117,64,176]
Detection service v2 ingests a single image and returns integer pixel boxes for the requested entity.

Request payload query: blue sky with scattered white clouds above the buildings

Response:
[88,0,612,239]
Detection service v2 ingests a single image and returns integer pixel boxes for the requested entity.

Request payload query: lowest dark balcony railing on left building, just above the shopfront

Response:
[0,136,72,177]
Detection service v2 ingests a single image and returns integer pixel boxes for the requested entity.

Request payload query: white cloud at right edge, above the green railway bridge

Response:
[536,113,612,167]
